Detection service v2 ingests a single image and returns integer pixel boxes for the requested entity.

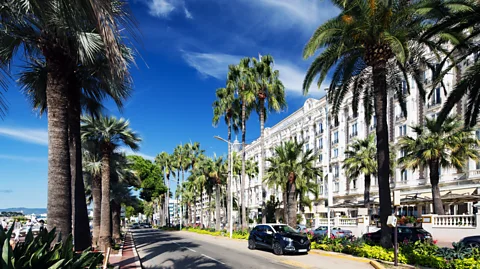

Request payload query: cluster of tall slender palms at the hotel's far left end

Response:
[213,55,287,229]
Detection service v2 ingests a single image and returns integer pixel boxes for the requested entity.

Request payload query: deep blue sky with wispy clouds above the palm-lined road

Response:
[0,0,337,208]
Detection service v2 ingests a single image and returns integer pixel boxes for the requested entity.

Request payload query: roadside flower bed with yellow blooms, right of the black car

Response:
[312,238,480,269]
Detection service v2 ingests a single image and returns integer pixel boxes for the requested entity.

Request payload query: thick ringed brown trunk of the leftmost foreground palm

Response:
[44,56,74,241]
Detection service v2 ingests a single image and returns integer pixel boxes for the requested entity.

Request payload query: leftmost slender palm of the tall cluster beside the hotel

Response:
[212,86,241,230]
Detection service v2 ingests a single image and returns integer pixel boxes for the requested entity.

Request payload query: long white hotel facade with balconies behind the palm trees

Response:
[234,54,480,224]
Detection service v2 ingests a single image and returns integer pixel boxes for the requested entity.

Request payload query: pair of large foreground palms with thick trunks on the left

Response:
[0,0,135,250]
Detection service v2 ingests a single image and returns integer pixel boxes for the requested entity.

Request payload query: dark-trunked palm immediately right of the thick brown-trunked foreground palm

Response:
[18,51,133,250]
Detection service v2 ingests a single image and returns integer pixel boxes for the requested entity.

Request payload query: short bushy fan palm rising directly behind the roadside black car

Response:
[264,141,322,227]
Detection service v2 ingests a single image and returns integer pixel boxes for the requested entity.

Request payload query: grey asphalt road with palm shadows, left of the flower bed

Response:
[133,229,372,269]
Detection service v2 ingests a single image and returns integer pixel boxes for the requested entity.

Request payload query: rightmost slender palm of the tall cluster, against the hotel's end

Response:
[252,55,287,223]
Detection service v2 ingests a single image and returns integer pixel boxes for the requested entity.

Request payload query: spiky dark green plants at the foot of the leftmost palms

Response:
[0,225,103,269]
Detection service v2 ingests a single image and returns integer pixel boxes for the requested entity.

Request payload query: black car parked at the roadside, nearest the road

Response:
[248,224,310,255]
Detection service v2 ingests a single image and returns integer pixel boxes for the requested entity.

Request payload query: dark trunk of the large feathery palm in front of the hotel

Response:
[373,60,392,248]
